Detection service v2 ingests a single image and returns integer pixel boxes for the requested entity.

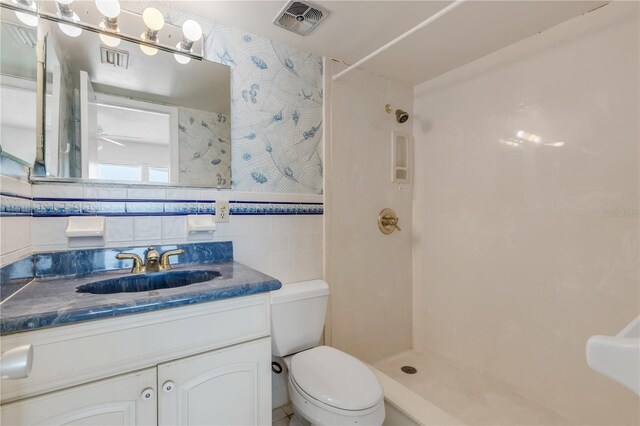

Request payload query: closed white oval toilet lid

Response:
[290,346,382,410]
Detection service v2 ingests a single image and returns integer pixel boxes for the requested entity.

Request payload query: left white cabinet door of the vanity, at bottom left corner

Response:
[0,368,157,426]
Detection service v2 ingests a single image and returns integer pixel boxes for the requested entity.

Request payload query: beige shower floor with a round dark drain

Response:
[374,351,576,425]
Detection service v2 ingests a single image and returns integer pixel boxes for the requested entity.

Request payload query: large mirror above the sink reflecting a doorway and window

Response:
[36,19,231,188]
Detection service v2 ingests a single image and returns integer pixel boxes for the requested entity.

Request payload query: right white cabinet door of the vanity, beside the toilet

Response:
[158,337,271,425]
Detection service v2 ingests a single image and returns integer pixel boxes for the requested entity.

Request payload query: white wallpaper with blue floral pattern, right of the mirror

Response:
[204,22,323,194]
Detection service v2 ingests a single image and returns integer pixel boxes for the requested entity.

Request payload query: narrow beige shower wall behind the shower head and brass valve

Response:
[325,60,413,362]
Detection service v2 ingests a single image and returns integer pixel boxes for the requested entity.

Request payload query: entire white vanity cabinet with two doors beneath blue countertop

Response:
[0,293,271,425]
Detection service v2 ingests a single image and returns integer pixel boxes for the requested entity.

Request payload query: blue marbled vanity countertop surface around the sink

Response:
[0,260,281,335]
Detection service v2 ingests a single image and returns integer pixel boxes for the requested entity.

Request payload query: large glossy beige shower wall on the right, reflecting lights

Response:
[412,2,640,424]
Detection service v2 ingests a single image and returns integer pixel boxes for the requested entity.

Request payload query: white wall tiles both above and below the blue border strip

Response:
[8,181,323,283]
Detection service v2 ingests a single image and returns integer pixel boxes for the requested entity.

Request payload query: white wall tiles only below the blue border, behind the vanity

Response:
[27,215,323,284]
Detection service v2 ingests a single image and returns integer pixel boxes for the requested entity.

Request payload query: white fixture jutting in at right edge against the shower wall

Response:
[587,316,640,395]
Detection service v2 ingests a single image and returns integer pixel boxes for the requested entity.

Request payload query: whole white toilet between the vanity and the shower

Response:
[271,280,384,425]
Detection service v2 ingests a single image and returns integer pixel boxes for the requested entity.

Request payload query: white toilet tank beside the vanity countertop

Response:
[271,280,329,356]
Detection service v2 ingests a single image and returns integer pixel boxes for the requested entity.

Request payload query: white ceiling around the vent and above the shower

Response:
[178,0,607,84]
